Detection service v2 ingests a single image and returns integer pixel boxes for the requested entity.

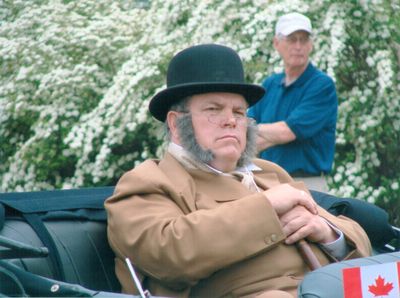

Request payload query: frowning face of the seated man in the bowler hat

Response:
[189,92,248,170]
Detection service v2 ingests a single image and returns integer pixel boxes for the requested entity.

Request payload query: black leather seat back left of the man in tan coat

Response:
[0,188,120,292]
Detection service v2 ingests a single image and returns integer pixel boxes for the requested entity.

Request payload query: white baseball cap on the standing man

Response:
[275,12,312,36]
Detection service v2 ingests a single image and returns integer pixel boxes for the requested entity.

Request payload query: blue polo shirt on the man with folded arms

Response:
[248,63,338,175]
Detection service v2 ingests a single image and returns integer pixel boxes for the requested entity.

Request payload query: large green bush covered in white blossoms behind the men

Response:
[0,0,400,221]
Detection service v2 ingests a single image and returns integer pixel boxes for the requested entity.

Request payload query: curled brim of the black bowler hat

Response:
[149,82,265,122]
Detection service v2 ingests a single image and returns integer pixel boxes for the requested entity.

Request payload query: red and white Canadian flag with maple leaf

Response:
[343,262,400,298]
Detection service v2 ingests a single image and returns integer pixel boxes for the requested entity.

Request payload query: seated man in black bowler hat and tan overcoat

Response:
[105,44,371,297]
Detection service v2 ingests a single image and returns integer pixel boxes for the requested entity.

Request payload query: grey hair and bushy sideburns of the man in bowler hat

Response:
[164,97,258,167]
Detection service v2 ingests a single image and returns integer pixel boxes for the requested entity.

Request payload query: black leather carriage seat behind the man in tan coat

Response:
[0,187,399,294]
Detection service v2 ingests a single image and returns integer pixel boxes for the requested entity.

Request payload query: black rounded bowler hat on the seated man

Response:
[149,44,265,122]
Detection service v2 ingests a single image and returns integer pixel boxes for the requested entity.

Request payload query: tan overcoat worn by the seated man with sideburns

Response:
[105,153,371,297]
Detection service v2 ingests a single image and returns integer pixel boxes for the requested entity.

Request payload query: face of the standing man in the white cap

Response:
[274,31,312,68]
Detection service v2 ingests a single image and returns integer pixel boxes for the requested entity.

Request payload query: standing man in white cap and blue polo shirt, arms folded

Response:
[248,13,338,192]
